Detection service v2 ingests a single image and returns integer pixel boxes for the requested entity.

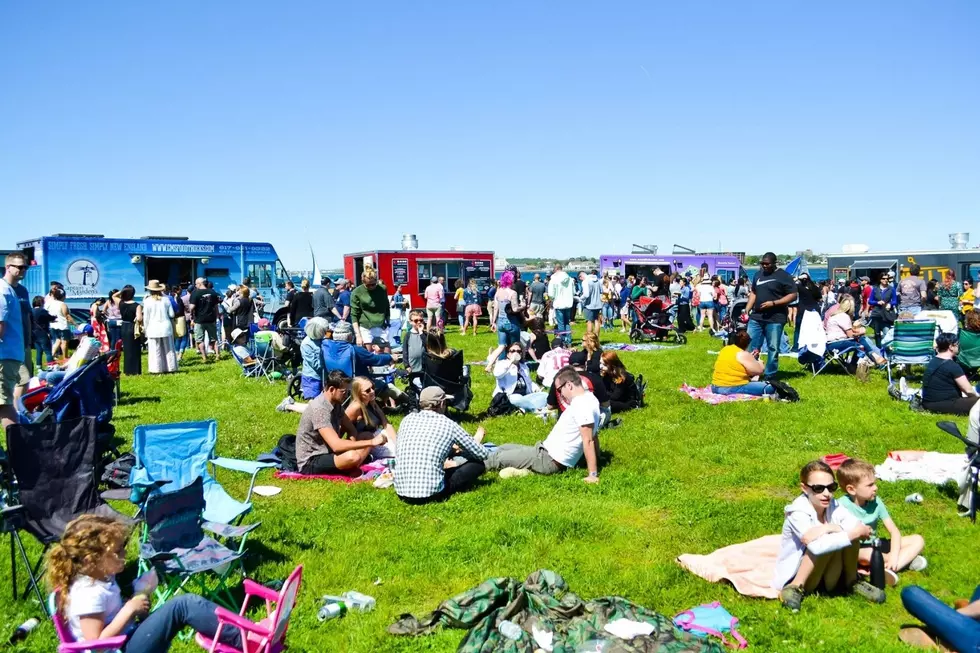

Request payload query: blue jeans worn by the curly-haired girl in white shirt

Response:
[124,594,242,653]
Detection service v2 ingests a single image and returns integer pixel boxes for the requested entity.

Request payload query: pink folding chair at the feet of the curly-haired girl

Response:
[195,565,303,653]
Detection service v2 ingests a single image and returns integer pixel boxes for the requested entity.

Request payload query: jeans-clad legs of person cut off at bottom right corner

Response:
[898,585,980,651]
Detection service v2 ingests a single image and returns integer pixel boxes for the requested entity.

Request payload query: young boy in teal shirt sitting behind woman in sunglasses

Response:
[837,458,927,586]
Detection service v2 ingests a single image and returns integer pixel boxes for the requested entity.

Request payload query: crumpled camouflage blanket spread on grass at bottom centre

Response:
[388,569,724,653]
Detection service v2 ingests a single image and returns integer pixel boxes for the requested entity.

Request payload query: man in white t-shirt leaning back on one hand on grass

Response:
[485,367,601,483]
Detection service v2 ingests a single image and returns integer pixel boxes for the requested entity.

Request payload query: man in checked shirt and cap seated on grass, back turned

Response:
[395,386,487,505]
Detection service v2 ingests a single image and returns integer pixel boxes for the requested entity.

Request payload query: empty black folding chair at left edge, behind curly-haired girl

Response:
[2,417,132,609]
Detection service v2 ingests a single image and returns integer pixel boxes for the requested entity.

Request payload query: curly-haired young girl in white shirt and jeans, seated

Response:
[47,515,241,653]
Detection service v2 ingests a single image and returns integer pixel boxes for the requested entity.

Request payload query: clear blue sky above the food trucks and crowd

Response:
[0,0,980,268]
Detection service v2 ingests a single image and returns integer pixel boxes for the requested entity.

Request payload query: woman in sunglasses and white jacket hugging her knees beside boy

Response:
[772,460,885,612]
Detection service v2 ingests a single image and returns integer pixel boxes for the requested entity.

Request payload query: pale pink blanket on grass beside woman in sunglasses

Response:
[677,535,782,599]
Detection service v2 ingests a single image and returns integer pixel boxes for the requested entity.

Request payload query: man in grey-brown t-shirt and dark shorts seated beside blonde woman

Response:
[296,370,388,476]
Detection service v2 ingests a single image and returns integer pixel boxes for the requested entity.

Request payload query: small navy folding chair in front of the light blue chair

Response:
[139,478,258,610]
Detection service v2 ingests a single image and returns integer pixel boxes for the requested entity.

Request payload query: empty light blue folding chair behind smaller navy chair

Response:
[130,419,275,524]
